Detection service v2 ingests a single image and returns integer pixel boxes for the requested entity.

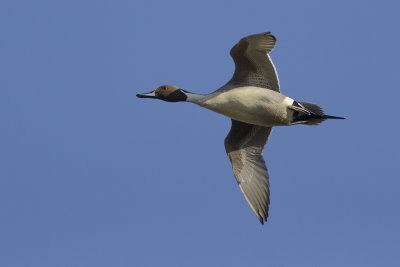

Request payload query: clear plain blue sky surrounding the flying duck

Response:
[0,0,400,267]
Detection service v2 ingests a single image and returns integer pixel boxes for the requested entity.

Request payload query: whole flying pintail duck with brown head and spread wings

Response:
[136,32,344,224]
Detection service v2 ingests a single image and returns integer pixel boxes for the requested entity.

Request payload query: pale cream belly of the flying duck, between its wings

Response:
[202,87,293,126]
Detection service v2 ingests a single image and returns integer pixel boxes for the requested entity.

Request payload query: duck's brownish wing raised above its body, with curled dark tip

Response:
[228,32,279,92]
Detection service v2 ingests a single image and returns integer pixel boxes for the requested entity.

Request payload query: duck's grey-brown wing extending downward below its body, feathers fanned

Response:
[225,120,272,224]
